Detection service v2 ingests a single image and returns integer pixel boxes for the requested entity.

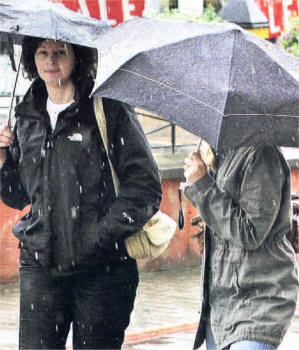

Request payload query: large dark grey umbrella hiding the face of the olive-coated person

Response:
[93,18,299,149]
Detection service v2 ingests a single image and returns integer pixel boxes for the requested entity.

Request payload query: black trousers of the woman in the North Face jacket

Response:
[19,260,138,350]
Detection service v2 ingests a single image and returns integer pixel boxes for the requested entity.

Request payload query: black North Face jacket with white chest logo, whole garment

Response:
[1,80,162,271]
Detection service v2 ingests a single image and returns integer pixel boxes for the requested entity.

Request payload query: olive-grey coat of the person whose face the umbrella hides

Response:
[185,146,298,350]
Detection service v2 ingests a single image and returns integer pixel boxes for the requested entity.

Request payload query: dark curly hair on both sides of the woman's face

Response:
[22,36,96,85]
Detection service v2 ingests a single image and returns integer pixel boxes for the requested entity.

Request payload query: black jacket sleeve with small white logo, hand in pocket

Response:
[99,104,162,246]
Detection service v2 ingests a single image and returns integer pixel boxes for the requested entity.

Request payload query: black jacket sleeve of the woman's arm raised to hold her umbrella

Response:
[0,131,29,210]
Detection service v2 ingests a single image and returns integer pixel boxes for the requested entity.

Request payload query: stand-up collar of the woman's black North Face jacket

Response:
[15,78,92,119]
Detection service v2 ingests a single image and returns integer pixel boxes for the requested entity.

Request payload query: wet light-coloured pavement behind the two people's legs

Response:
[0,267,299,350]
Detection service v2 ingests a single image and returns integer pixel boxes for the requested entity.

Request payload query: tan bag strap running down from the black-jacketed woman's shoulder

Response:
[93,96,119,196]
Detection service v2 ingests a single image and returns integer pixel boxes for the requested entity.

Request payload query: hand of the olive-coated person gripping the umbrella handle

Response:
[184,152,207,185]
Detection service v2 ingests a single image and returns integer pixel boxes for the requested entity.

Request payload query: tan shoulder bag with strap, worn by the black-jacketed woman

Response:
[94,97,177,259]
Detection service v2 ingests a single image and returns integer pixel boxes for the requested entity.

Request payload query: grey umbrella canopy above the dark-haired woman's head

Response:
[0,0,110,47]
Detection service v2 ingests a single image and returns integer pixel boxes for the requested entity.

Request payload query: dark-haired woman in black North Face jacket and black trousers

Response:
[0,37,162,349]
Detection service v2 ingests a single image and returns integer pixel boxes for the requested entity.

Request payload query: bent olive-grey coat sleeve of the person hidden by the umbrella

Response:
[185,147,288,250]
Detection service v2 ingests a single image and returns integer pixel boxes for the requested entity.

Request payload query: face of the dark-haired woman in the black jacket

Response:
[34,40,75,87]
